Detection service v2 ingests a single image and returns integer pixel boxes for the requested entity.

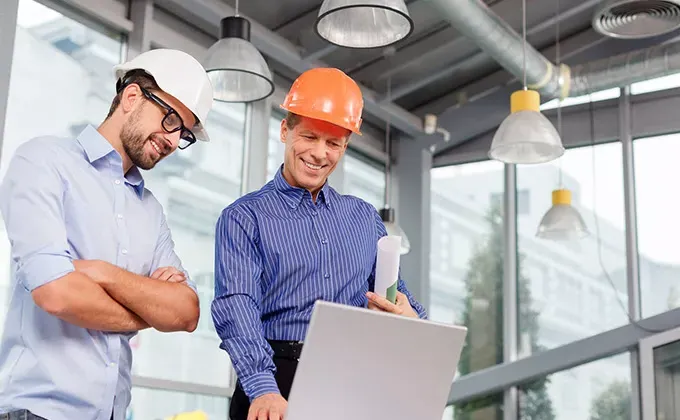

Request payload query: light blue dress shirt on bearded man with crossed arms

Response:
[0,126,196,420]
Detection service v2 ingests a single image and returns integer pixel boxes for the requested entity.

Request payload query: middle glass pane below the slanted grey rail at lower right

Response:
[519,353,632,420]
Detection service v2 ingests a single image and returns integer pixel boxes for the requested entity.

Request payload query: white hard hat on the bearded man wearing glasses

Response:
[113,48,213,141]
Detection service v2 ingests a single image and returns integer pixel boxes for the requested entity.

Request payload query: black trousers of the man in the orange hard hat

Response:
[229,341,302,420]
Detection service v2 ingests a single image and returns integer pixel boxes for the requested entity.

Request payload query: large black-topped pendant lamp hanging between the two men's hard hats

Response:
[204,16,274,102]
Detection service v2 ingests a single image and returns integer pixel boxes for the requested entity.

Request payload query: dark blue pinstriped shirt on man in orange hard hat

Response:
[212,169,426,400]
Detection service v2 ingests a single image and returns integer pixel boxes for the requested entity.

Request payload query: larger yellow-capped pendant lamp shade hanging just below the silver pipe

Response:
[489,90,564,164]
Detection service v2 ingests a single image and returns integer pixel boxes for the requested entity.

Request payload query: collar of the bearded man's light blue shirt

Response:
[76,124,144,198]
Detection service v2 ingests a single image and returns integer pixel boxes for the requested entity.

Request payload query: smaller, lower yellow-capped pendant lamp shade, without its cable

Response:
[536,189,589,241]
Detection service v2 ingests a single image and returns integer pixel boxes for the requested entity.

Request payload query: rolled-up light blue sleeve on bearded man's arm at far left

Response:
[0,145,74,291]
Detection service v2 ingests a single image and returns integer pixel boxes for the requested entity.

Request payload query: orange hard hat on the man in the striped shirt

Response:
[281,67,364,135]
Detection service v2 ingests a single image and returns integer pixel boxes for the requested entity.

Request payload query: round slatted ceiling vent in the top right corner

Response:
[593,0,680,39]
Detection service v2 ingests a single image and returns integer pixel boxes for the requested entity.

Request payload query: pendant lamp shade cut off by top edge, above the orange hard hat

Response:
[314,0,413,48]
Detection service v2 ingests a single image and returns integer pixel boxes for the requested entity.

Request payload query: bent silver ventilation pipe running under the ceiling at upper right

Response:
[430,0,680,100]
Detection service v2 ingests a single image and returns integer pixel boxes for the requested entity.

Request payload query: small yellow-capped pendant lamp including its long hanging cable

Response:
[536,0,588,240]
